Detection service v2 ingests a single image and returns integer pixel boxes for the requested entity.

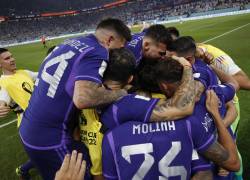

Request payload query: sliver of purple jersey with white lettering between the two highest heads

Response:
[126,32,145,65]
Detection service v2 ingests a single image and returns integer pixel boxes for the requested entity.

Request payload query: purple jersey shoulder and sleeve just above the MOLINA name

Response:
[101,94,159,129]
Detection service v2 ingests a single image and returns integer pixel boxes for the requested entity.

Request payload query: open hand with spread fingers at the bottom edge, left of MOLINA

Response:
[55,150,86,180]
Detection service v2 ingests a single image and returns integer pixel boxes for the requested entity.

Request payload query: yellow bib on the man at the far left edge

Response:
[0,70,34,127]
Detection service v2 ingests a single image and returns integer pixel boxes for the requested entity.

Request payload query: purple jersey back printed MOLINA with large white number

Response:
[103,118,192,180]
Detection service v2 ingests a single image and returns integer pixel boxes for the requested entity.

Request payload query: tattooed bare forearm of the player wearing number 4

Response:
[73,80,127,109]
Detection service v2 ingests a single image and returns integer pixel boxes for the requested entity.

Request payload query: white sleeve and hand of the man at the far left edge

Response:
[0,88,11,117]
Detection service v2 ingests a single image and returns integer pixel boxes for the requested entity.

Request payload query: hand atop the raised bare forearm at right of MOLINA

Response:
[206,90,220,115]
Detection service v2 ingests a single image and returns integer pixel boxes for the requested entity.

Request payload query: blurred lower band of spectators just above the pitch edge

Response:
[0,0,250,44]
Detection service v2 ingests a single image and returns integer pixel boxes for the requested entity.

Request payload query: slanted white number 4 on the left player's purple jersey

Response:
[41,51,75,98]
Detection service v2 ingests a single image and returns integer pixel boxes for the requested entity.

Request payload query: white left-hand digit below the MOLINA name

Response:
[122,143,154,180]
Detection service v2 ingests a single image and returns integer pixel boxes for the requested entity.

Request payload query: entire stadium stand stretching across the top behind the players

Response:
[0,0,250,45]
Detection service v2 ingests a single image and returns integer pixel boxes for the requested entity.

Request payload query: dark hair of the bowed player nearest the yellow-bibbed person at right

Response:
[168,36,196,55]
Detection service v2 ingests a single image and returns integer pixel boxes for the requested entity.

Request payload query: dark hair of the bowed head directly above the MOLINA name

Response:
[155,58,183,83]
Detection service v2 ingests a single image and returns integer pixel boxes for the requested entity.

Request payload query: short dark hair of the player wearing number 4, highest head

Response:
[96,18,132,41]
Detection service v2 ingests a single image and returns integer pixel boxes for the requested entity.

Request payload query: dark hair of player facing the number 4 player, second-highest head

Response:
[145,24,172,46]
